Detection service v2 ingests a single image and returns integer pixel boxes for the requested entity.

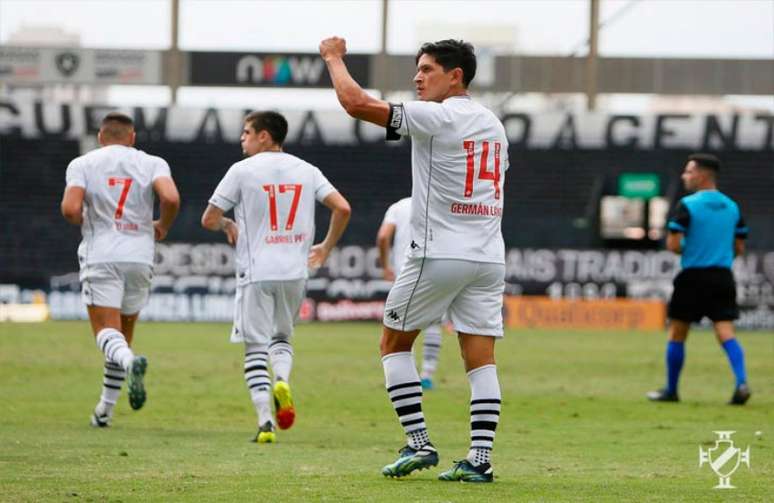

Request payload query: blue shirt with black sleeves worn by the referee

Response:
[667,190,748,269]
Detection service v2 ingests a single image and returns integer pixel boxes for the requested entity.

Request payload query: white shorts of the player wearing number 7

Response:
[80,262,153,315]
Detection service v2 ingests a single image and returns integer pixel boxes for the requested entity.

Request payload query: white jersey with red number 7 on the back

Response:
[66,145,171,268]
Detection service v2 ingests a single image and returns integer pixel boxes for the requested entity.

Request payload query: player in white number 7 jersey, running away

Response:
[61,112,180,427]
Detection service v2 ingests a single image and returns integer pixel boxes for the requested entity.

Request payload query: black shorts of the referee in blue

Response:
[668,267,739,322]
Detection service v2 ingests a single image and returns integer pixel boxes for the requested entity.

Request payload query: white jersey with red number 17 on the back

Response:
[210,152,336,285]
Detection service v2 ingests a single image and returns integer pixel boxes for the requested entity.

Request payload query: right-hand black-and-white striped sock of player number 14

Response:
[467,365,501,466]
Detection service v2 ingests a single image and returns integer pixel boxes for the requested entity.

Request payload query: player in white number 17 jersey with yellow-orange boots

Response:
[202,111,350,443]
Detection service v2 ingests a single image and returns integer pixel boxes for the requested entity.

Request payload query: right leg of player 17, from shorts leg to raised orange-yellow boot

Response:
[269,280,305,430]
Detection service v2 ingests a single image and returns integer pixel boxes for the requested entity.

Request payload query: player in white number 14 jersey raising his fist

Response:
[320,37,508,482]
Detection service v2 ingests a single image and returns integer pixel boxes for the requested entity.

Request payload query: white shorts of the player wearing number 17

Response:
[231,279,306,345]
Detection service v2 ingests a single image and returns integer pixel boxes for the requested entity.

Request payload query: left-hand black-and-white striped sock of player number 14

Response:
[382,351,430,449]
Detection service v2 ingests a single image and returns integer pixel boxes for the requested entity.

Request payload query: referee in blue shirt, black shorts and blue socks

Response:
[647,154,750,405]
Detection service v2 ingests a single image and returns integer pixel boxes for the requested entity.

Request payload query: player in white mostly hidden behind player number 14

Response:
[376,197,441,390]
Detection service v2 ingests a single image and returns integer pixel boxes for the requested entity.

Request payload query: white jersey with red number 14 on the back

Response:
[390,96,508,264]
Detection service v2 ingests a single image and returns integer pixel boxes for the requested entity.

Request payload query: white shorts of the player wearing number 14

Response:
[384,257,505,337]
